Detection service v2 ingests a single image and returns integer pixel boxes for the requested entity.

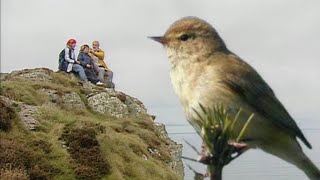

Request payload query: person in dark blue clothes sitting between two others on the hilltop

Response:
[78,44,103,85]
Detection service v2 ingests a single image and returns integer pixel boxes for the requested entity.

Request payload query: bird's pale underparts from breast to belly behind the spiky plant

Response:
[170,65,275,148]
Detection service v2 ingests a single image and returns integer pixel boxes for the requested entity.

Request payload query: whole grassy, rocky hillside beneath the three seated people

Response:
[0,68,183,180]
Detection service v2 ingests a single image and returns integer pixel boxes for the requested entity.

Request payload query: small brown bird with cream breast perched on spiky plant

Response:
[151,17,320,180]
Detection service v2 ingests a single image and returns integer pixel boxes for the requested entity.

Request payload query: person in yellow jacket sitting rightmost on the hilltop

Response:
[89,41,115,89]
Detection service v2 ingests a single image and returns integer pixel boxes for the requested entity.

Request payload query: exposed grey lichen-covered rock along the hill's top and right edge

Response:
[1,68,184,177]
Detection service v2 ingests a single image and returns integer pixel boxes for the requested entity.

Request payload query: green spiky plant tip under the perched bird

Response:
[191,105,254,180]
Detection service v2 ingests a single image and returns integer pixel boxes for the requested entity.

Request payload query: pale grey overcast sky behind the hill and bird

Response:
[1,0,320,179]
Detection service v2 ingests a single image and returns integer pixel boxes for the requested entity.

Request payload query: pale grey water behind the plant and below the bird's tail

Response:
[151,107,320,180]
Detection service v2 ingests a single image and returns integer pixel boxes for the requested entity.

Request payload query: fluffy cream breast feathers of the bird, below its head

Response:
[170,59,232,113]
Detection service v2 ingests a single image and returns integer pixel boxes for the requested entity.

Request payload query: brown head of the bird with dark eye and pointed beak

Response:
[150,17,226,63]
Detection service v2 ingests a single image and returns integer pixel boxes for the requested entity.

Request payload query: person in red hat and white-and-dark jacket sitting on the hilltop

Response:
[59,39,88,81]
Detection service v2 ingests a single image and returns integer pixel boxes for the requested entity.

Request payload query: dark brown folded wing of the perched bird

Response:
[221,59,312,149]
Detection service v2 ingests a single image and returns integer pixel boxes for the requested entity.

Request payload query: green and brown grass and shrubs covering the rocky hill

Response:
[0,69,181,180]
